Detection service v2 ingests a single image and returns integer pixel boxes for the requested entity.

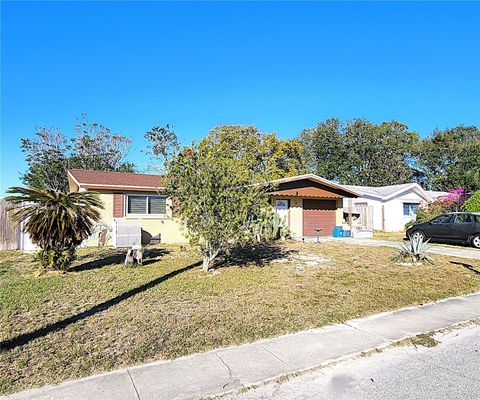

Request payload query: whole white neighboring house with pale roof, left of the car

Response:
[343,183,436,232]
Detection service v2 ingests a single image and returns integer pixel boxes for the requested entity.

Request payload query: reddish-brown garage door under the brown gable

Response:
[303,199,337,236]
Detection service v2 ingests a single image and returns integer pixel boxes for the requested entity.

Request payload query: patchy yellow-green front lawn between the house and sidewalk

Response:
[0,242,480,394]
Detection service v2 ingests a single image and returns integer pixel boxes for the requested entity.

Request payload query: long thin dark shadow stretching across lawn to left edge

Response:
[0,262,201,351]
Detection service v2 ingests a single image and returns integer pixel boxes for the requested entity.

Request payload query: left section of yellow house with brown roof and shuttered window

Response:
[68,169,187,245]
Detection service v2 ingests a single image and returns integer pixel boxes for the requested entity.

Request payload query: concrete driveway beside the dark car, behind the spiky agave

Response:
[330,238,480,260]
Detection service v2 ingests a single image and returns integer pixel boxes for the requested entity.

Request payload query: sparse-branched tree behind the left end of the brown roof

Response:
[21,114,134,192]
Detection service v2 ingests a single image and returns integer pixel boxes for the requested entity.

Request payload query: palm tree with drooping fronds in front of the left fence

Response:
[6,187,103,270]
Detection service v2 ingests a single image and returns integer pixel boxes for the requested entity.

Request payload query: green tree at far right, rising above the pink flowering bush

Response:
[418,125,480,191]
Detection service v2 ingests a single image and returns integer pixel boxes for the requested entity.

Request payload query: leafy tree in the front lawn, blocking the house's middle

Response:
[167,140,269,271]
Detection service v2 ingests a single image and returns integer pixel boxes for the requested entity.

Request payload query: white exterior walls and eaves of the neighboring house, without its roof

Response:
[343,190,425,232]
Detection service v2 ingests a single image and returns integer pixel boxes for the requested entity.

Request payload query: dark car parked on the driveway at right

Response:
[407,212,480,249]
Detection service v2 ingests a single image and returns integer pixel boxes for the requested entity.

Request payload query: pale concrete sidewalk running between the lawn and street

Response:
[7,292,480,400]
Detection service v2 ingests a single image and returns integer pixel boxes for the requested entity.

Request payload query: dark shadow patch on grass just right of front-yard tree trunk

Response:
[218,243,298,269]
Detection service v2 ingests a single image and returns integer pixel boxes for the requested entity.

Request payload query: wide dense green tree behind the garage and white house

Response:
[299,118,419,186]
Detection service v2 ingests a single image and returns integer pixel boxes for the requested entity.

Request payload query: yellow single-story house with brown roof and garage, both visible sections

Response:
[68,169,358,245]
